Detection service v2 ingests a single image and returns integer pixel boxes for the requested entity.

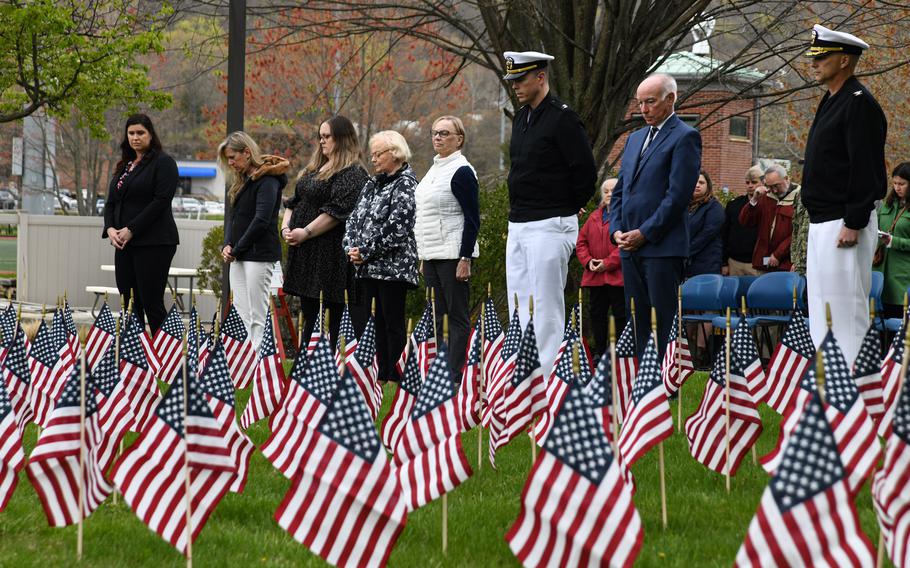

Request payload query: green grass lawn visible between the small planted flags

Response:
[0,373,892,567]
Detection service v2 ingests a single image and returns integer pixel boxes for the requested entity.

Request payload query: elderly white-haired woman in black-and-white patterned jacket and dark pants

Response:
[342,130,417,381]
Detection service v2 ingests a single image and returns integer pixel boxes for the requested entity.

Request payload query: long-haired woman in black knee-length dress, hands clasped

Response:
[281,116,368,344]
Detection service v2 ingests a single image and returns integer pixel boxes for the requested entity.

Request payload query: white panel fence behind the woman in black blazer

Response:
[10,212,222,317]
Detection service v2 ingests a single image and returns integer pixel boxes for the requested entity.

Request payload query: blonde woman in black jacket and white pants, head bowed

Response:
[218,131,289,349]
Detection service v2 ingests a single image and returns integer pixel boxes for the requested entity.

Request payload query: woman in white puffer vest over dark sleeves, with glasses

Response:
[414,116,480,373]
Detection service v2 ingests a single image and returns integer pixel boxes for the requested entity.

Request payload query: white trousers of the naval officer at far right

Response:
[806,211,878,368]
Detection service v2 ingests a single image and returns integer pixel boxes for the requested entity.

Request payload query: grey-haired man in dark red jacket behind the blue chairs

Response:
[739,164,799,272]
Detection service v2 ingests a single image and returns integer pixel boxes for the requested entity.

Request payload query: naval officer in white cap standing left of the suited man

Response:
[503,51,597,370]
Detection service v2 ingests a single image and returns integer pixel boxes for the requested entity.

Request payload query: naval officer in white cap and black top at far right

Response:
[802,25,888,366]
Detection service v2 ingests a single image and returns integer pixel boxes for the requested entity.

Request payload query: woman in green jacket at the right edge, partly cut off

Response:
[873,162,910,318]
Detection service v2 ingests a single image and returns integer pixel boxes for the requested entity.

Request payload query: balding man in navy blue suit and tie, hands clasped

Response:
[610,74,701,358]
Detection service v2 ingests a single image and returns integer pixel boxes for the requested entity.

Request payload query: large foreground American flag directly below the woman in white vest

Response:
[394,343,473,511]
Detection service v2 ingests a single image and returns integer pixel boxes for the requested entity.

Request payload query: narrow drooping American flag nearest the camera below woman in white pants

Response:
[199,341,256,493]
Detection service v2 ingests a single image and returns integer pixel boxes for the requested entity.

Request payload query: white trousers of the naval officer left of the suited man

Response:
[506,215,578,374]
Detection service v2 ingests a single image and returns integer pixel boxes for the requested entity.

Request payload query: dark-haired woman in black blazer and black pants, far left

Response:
[101,114,180,334]
